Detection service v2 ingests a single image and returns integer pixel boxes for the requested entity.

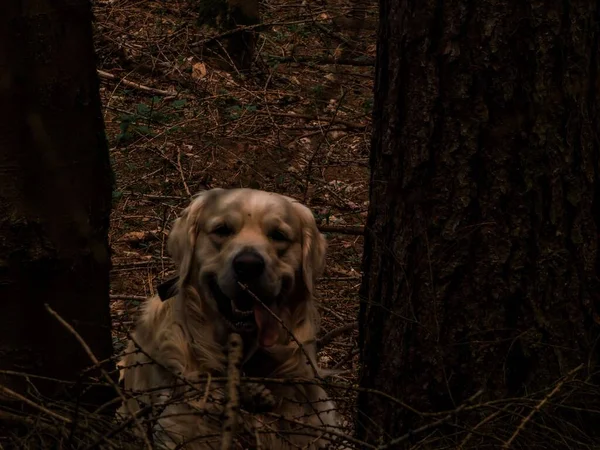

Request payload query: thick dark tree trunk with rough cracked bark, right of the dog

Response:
[357,0,600,448]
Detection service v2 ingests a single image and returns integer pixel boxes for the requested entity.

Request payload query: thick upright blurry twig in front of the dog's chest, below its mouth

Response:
[221,333,244,450]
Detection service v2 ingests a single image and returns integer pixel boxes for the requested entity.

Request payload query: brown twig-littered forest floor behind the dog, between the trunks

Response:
[94,0,377,440]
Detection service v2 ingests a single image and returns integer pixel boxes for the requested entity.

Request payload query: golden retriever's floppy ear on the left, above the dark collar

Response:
[167,189,221,282]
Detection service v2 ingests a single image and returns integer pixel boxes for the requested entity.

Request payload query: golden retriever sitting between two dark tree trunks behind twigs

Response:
[119,188,339,450]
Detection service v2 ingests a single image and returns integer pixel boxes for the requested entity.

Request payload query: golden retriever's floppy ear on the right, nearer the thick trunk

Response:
[290,199,327,294]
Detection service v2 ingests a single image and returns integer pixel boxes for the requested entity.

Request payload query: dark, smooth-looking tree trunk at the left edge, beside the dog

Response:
[0,0,112,400]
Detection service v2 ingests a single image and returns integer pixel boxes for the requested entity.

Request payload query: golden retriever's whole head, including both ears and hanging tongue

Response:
[169,189,325,347]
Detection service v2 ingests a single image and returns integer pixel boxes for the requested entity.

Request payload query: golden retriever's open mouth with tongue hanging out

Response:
[209,277,280,347]
